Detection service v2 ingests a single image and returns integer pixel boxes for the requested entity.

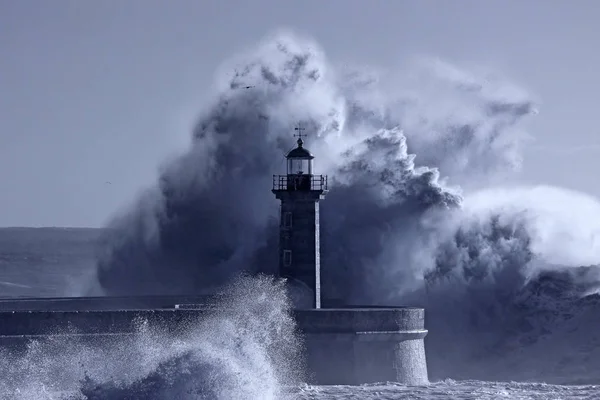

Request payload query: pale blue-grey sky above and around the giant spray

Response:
[0,0,600,227]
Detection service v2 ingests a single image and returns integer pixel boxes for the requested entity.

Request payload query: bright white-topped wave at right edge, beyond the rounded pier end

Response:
[418,186,600,383]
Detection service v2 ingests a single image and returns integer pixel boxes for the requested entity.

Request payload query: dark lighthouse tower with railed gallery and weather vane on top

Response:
[273,127,327,308]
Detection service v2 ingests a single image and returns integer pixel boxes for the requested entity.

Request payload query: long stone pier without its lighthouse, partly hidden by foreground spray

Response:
[0,296,428,385]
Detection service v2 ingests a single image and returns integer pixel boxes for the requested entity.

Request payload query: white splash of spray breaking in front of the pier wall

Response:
[0,276,303,400]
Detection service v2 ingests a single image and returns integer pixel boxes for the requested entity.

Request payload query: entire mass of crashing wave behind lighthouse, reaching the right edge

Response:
[88,33,600,379]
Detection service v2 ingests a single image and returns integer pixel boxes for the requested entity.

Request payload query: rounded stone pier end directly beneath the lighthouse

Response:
[295,307,429,385]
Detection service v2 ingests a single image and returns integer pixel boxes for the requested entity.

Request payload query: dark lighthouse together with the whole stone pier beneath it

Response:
[0,127,428,386]
